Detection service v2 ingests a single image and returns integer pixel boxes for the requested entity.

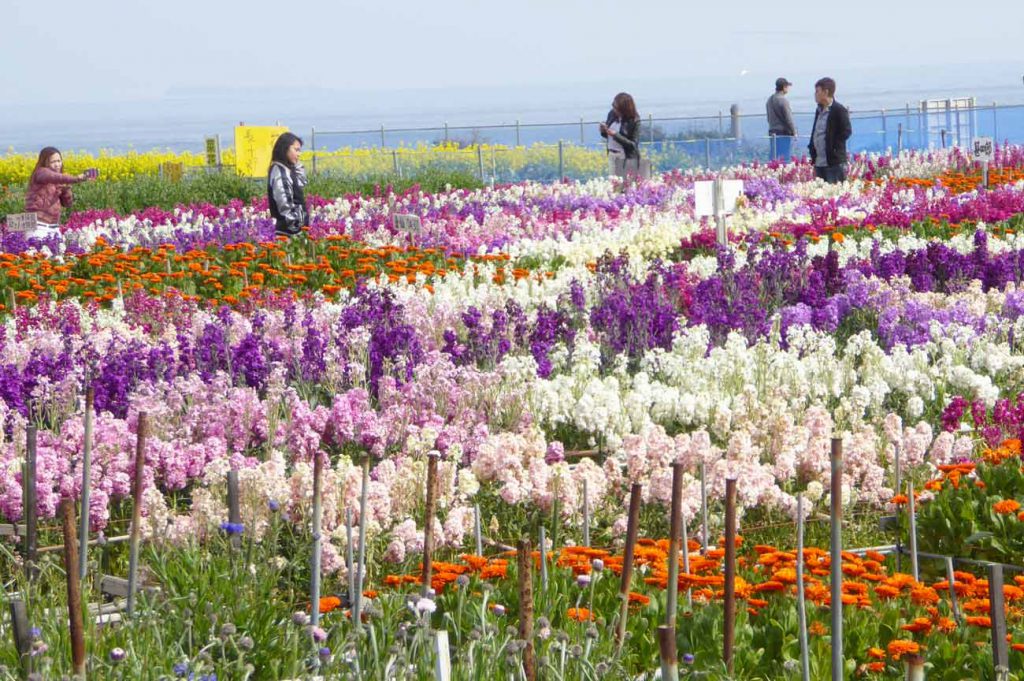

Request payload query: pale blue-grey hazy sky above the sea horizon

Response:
[6,0,1024,103]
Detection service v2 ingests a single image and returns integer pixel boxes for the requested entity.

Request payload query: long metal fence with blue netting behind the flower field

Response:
[290,99,1024,182]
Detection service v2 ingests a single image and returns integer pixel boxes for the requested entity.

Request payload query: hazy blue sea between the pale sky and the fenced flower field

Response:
[0,62,1024,153]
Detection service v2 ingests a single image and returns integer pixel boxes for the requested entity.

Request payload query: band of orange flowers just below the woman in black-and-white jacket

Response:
[0,231,536,310]
